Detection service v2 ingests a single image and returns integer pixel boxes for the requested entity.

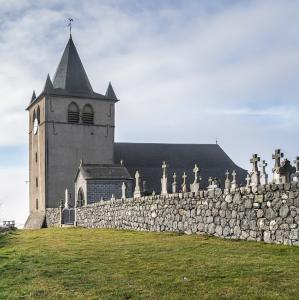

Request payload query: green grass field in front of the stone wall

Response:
[0,228,299,299]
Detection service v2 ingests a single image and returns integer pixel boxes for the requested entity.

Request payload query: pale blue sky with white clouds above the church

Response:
[0,0,299,225]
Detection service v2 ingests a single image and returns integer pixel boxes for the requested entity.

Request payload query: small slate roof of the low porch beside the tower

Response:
[75,164,132,181]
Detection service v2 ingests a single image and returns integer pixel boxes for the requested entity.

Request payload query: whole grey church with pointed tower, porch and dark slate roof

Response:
[25,35,247,228]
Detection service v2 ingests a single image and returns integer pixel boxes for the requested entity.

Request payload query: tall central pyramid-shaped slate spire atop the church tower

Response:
[53,35,93,94]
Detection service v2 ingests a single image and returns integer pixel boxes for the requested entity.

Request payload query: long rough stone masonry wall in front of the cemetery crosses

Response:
[73,183,299,246]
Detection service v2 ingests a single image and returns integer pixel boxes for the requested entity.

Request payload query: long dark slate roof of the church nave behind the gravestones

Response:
[114,143,247,192]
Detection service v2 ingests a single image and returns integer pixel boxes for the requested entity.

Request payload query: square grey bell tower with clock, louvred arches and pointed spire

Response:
[25,35,118,228]
